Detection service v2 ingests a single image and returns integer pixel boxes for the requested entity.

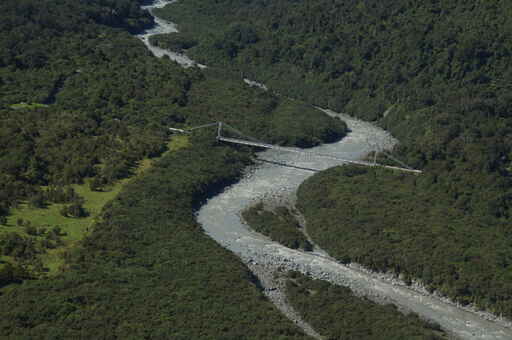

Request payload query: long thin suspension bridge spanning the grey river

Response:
[169,122,422,174]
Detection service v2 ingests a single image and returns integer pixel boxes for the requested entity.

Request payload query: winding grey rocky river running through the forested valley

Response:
[137,0,512,340]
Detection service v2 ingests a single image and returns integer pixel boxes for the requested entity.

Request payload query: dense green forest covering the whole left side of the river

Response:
[0,0,346,339]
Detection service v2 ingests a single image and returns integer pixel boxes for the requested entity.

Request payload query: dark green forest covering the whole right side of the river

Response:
[161,0,512,317]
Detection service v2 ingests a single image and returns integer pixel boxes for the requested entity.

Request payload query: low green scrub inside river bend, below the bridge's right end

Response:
[298,166,512,315]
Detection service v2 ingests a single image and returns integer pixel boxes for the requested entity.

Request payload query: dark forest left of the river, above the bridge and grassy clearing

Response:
[0,0,346,281]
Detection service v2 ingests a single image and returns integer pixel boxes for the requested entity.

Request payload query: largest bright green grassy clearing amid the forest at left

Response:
[0,136,189,275]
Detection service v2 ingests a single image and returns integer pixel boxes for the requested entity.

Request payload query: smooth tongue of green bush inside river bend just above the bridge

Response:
[178,69,347,147]
